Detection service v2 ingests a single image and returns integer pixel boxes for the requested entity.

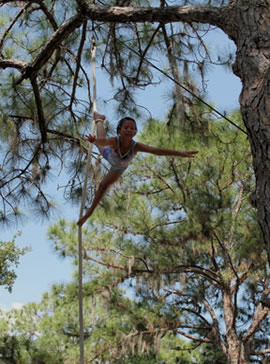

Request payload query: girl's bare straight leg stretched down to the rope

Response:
[77,169,121,226]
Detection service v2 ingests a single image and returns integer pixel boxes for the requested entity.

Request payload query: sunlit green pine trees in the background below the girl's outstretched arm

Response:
[3,114,269,364]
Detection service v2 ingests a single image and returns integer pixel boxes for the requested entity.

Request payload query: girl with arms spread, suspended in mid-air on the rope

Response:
[77,112,198,226]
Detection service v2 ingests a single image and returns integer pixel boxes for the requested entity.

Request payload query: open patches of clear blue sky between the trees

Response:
[0,32,241,309]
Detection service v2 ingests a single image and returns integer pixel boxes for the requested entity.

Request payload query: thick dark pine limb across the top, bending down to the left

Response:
[0,0,232,84]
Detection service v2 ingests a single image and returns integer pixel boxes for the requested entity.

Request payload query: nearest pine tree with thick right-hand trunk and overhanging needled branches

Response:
[0,0,270,262]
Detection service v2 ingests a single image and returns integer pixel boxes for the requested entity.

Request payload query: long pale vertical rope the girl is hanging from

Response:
[78,35,97,364]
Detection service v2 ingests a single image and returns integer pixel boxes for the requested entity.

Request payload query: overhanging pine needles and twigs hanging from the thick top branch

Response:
[0,0,232,224]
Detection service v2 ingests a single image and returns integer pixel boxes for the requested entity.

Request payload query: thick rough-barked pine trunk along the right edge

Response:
[224,0,270,263]
